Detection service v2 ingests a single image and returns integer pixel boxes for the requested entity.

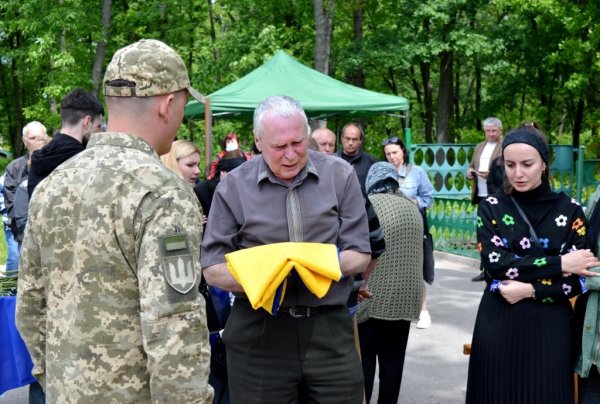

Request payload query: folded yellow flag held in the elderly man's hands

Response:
[225,242,342,314]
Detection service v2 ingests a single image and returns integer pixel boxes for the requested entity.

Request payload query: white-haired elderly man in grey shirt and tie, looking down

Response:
[201,96,370,403]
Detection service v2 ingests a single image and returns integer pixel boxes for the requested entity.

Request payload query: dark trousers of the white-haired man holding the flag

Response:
[223,299,363,404]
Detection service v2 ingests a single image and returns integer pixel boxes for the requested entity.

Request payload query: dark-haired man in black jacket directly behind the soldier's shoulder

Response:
[27,88,104,197]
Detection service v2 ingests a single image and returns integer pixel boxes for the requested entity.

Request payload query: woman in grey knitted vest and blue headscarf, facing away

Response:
[357,162,423,403]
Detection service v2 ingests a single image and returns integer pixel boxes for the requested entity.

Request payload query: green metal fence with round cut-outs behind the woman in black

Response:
[411,144,600,257]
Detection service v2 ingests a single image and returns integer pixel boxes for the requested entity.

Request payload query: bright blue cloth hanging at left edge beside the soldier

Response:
[0,296,35,394]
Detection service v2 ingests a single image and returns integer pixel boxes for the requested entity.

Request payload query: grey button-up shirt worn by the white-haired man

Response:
[200,150,371,307]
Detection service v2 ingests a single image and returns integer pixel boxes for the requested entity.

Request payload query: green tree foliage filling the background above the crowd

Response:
[0,0,600,161]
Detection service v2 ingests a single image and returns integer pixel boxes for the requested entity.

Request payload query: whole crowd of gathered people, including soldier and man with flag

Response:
[2,40,600,404]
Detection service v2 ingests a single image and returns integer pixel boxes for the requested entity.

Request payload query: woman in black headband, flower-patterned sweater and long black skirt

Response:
[466,127,598,404]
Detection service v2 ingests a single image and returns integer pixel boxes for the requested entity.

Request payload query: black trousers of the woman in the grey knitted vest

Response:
[358,318,410,404]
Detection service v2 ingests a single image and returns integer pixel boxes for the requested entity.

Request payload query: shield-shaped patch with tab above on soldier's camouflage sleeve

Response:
[160,233,197,295]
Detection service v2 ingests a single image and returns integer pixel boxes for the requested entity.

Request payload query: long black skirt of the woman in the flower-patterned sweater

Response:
[466,289,574,404]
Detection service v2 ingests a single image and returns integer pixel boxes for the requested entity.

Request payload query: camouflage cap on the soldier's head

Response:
[104,39,204,102]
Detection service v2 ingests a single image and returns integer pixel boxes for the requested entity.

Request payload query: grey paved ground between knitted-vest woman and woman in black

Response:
[0,252,483,404]
